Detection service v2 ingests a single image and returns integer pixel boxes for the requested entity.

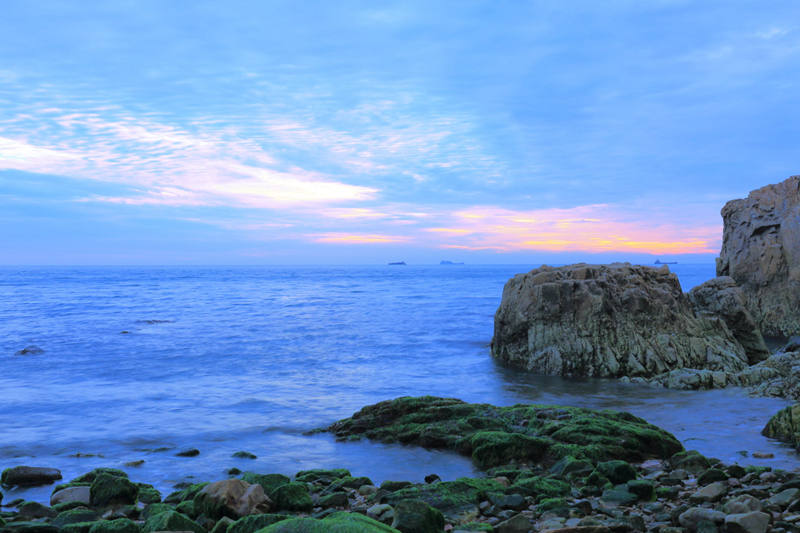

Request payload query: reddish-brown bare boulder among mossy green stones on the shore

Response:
[192,479,270,520]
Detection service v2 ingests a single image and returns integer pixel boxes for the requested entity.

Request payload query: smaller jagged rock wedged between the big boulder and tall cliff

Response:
[689,276,769,365]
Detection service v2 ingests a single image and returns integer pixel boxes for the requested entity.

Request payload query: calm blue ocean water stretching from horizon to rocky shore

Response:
[0,264,800,499]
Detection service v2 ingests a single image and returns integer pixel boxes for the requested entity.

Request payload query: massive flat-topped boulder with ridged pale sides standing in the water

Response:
[492,263,752,377]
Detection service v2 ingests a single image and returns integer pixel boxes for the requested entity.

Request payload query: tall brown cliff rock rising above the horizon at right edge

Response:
[717,176,800,336]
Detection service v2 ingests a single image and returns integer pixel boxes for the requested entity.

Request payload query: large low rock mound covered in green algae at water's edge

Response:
[327,396,683,468]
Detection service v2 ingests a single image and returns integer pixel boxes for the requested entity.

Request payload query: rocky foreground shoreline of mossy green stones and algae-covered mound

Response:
[0,397,800,533]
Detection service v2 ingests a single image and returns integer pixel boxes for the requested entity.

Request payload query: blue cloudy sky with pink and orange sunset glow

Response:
[0,0,800,265]
